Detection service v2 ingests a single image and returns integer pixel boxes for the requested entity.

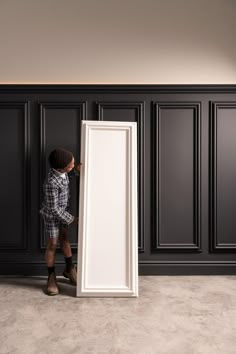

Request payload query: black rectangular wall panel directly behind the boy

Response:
[40,102,86,248]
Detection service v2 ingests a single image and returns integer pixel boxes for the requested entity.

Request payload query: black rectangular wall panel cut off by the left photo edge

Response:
[0,102,30,249]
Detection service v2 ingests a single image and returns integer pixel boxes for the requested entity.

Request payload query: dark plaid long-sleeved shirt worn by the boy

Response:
[40,169,74,224]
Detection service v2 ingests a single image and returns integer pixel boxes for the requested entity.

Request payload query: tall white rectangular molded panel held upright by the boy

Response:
[77,121,138,297]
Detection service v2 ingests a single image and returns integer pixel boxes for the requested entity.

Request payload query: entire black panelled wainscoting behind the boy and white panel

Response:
[0,85,236,275]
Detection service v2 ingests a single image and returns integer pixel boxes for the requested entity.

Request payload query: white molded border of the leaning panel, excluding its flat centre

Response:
[76,121,138,297]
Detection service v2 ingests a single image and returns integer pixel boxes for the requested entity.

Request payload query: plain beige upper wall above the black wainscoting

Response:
[0,0,236,84]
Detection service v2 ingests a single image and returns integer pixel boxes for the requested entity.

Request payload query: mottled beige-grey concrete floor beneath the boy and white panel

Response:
[0,276,236,354]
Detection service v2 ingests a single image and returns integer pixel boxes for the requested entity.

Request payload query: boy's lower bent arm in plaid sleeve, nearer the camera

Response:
[45,183,74,224]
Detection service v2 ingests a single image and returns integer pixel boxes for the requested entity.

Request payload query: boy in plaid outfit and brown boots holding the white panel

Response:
[40,148,80,295]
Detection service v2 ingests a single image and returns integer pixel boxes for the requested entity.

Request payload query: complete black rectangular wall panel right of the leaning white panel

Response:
[153,103,200,251]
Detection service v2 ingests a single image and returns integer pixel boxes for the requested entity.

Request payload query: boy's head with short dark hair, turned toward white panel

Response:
[48,148,74,172]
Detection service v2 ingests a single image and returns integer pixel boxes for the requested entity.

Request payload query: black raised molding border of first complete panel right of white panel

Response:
[152,101,201,252]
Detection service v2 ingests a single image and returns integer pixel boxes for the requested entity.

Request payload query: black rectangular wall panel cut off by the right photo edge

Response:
[210,102,236,252]
